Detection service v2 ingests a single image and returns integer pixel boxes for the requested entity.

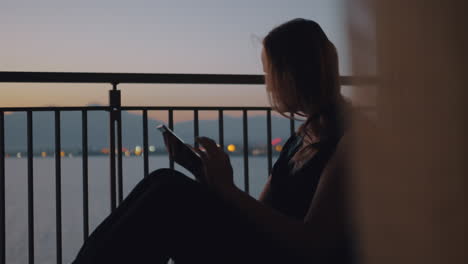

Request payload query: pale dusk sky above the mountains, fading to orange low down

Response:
[0,0,350,119]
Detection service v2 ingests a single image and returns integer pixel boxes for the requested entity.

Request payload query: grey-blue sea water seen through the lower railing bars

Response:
[5,155,277,264]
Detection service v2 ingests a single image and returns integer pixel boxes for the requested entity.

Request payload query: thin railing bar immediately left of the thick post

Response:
[81,110,89,240]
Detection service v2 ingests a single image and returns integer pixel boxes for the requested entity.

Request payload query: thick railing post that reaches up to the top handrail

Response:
[109,83,122,212]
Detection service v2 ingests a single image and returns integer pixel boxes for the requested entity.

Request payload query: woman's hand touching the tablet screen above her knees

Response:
[195,137,235,193]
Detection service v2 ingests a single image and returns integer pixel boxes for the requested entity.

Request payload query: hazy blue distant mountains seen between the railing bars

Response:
[5,111,299,152]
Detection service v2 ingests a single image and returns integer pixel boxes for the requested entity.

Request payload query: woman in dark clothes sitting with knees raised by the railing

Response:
[75,19,353,264]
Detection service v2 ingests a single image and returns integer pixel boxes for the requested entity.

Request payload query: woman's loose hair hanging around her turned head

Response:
[263,19,344,142]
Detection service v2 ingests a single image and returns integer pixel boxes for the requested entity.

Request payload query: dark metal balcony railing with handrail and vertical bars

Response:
[0,72,375,264]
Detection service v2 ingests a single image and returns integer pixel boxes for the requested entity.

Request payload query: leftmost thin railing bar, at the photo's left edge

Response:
[0,111,6,264]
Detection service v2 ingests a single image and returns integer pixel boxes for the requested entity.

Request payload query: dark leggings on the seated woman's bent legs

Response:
[73,169,290,264]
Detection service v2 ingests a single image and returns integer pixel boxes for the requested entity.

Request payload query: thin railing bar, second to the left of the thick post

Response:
[55,110,62,264]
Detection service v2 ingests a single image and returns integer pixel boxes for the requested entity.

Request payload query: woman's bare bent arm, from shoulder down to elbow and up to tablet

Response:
[195,139,352,260]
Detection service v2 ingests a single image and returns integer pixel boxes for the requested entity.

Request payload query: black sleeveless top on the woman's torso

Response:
[270,135,340,220]
